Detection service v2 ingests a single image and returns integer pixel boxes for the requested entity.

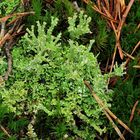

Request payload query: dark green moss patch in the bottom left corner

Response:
[0,111,29,140]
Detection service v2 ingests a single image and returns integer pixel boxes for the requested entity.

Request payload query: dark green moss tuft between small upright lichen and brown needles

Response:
[86,5,112,58]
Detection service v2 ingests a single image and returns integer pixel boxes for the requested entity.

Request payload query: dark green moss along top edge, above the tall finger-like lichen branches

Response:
[27,0,74,25]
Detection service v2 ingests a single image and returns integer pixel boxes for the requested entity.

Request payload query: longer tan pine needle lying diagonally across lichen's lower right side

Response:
[84,81,133,138]
